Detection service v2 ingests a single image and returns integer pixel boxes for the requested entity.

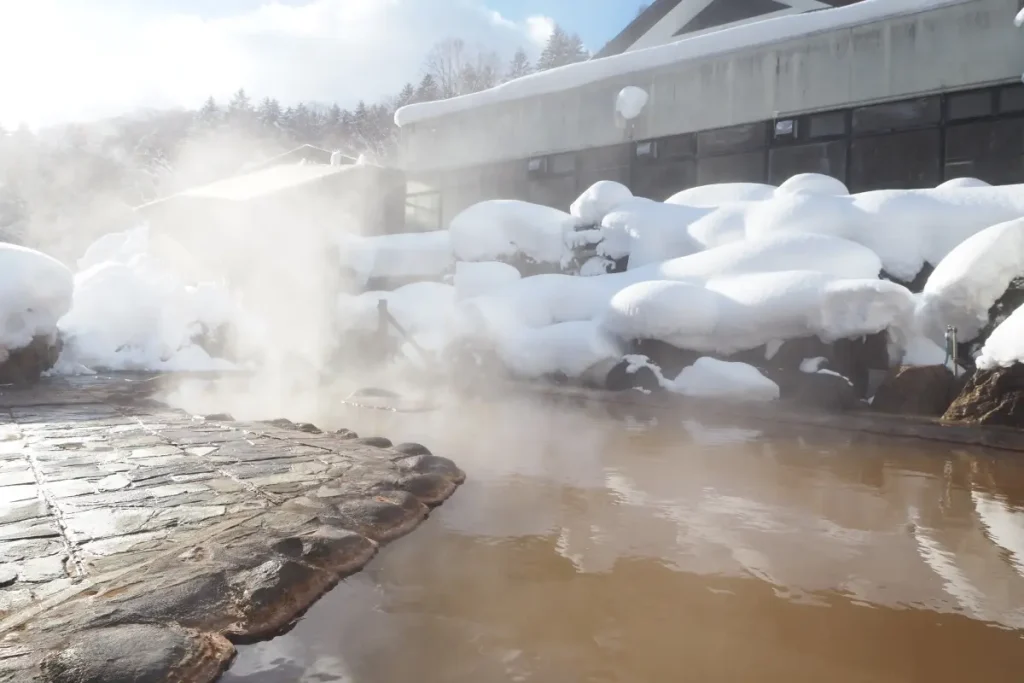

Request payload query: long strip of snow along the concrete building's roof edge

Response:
[394,0,972,126]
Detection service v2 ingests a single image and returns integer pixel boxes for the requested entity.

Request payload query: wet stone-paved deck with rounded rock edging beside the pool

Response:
[0,377,464,683]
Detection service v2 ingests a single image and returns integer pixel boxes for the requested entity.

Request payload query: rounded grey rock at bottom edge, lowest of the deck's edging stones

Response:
[41,624,234,683]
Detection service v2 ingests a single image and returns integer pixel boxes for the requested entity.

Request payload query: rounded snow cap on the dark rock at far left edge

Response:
[0,243,74,361]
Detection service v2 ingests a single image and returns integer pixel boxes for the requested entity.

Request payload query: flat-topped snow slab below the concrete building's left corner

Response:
[336,230,455,286]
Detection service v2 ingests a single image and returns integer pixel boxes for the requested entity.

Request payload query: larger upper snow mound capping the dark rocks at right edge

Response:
[918,218,1024,344]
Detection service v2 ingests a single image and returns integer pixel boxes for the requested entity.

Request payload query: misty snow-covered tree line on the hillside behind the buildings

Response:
[0,27,590,259]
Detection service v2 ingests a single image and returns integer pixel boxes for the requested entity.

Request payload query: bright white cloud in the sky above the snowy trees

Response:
[0,0,552,126]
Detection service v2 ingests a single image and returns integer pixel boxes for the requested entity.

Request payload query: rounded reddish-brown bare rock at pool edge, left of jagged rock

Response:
[871,366,963,417]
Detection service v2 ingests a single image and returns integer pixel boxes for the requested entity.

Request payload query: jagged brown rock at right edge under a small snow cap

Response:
[942,364,1024,428]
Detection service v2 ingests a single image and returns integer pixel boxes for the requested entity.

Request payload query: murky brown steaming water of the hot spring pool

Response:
[178,385,1024,683]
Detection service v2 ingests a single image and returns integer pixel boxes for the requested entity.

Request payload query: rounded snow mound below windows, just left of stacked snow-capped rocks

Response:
[449,200,580,263]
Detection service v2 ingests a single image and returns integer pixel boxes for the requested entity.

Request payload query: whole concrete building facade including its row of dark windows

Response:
[398,0,1024,228]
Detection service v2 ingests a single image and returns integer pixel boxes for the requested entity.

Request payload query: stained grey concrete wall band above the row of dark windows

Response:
[401,0,1024,174]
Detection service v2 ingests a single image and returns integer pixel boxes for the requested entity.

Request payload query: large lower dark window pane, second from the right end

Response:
[847,129,941,193]
